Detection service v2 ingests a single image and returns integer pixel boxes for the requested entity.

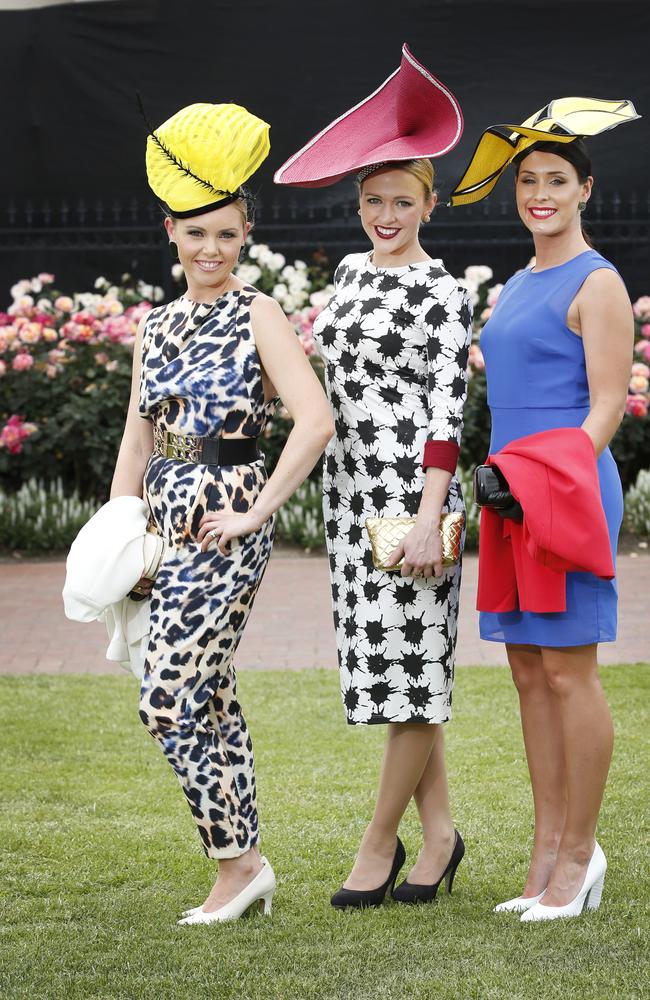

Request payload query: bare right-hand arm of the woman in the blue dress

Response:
[575,268,634,455]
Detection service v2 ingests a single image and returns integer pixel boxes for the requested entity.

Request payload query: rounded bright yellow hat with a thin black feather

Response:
[146,104,271,217]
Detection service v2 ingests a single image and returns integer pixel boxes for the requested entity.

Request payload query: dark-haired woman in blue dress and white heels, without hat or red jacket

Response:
[450,107,633,921]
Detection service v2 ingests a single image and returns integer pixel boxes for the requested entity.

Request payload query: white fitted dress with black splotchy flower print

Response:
[314,254,471,724]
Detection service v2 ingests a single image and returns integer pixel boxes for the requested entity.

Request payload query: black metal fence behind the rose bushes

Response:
[0,192,650,300]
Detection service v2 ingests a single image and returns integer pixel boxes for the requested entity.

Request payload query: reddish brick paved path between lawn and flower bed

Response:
[0,552,650,674]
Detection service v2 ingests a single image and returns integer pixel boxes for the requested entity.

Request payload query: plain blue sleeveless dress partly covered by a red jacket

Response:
[480,250,623,646]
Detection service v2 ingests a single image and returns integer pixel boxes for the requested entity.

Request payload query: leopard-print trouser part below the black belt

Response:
[140,456,273,858]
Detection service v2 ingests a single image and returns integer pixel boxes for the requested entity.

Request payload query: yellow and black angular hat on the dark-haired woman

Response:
[449,97,641,205]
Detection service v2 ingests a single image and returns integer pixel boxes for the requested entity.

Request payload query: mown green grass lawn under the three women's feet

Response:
[0,666,650,1000]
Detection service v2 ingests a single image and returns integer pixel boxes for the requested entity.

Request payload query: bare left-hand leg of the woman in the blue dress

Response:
[506,644,567,896]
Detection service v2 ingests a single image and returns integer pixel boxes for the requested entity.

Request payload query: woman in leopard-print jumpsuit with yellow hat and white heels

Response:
[111,105,333,923]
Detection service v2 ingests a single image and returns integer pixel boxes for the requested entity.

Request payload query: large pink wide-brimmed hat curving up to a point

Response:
[274,44,463,187]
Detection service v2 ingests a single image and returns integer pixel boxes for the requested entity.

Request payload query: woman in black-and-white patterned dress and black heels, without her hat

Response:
[314,159,471,906]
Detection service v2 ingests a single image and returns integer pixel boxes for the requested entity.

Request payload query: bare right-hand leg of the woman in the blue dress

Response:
[542,644,614,906]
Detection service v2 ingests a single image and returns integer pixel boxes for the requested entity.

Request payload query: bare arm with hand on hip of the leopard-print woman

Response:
[197,295,334,551]
